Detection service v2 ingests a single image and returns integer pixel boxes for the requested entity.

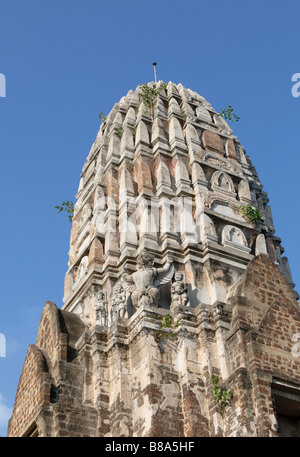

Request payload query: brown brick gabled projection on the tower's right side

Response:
[227,255,300,436]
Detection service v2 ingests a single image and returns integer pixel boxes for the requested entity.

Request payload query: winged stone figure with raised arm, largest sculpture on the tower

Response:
[121,251,174,308]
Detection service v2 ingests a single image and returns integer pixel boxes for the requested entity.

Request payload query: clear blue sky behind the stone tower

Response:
[0,0,300,436]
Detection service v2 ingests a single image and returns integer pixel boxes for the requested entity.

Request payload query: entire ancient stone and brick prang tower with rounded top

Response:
[8,81,300,437]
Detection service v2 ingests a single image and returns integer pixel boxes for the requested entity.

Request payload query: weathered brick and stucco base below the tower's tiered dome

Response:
[9,256,300,437]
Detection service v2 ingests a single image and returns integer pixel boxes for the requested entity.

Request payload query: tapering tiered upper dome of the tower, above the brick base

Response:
[64,81,293,325]
